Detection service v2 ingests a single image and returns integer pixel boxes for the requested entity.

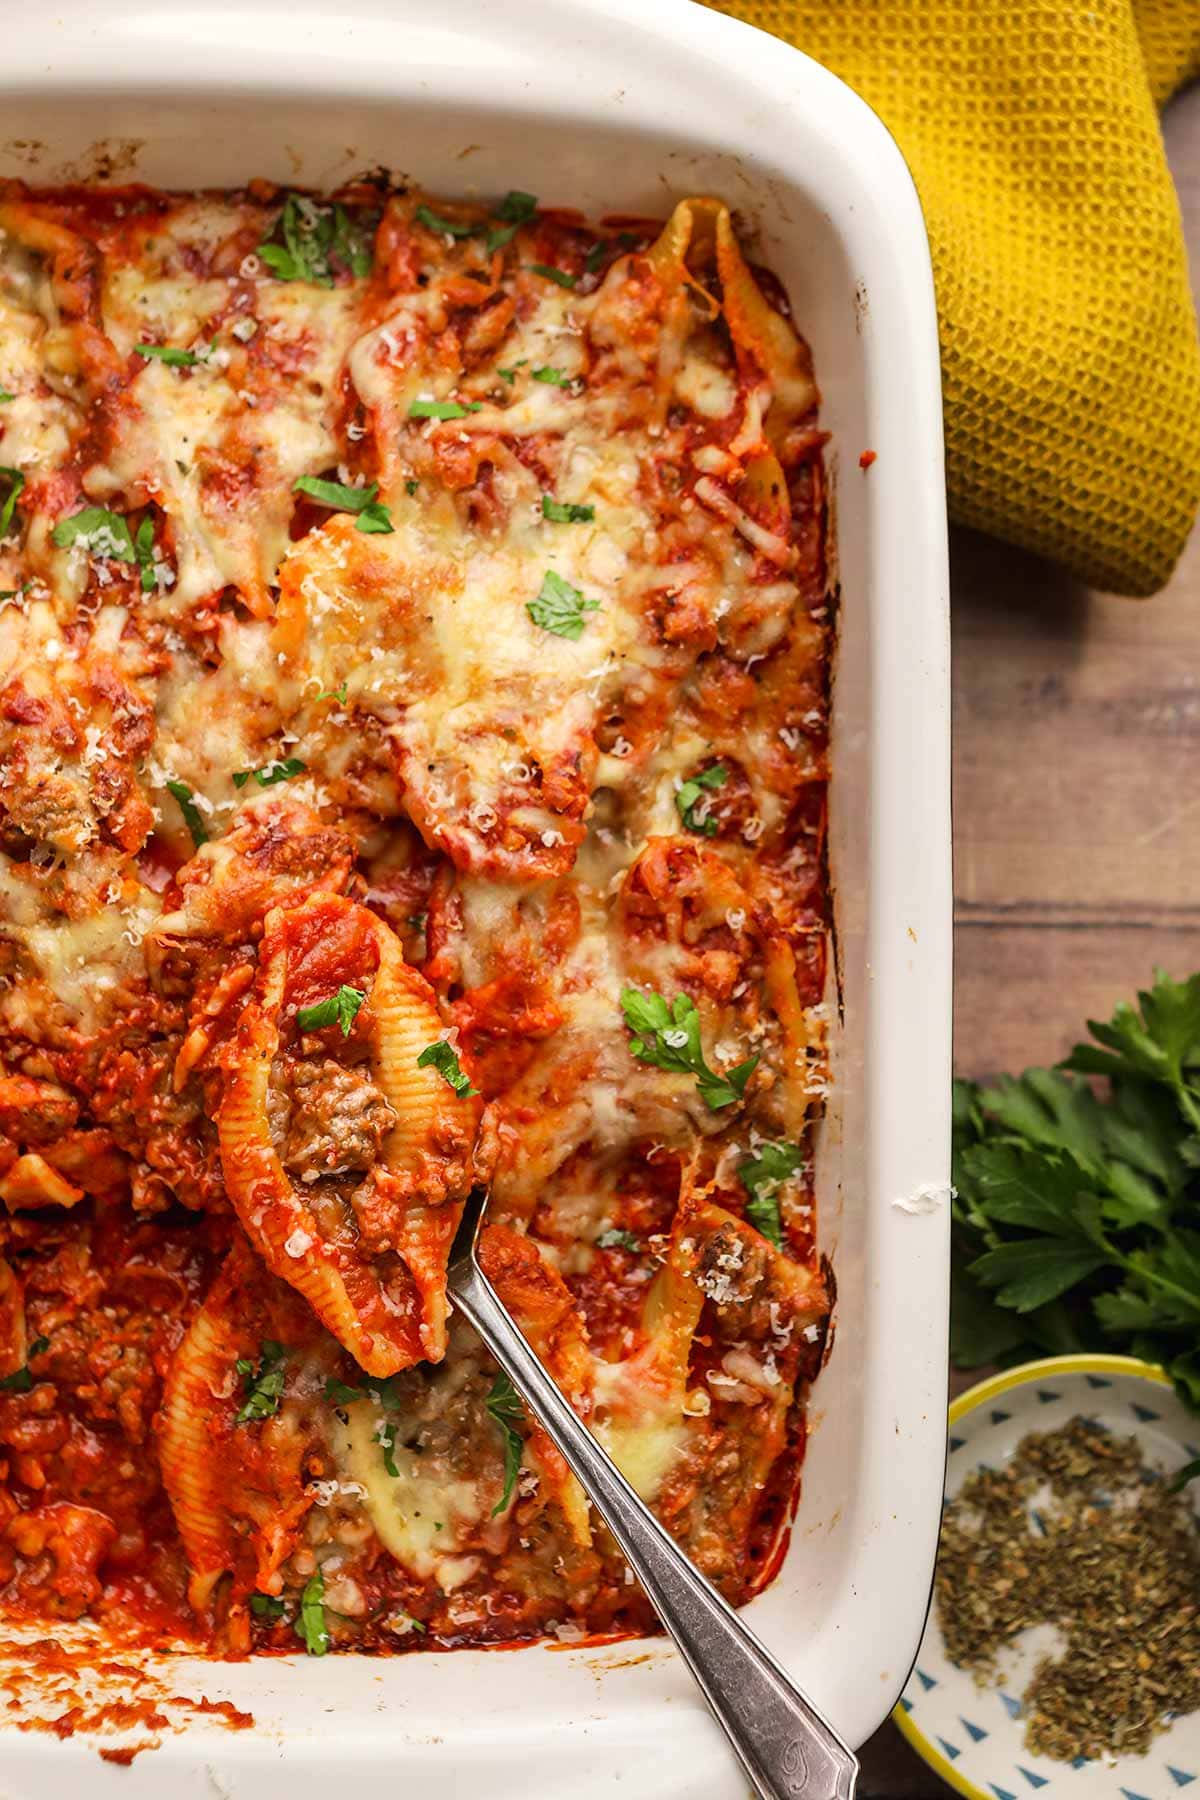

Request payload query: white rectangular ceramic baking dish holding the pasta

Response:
[0,0,950,1800]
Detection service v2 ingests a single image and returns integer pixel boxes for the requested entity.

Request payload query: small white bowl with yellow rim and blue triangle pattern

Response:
[894,1355,1200,1800]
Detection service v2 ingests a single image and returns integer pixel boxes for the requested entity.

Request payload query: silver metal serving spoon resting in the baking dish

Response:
[448,1188,858,1800]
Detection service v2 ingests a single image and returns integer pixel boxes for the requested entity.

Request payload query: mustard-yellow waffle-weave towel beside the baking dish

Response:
[716,0,1200,594]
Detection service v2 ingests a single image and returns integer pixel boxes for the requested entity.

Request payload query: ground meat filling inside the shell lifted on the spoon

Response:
[272,1057,399,1183]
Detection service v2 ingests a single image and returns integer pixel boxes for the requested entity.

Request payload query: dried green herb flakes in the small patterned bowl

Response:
[936,1418,1200,1760]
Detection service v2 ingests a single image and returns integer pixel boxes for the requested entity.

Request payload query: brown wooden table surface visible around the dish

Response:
[858,86,1200,1800]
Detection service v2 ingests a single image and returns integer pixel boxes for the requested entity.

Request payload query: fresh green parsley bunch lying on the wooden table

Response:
[950,970,1200,1411]
